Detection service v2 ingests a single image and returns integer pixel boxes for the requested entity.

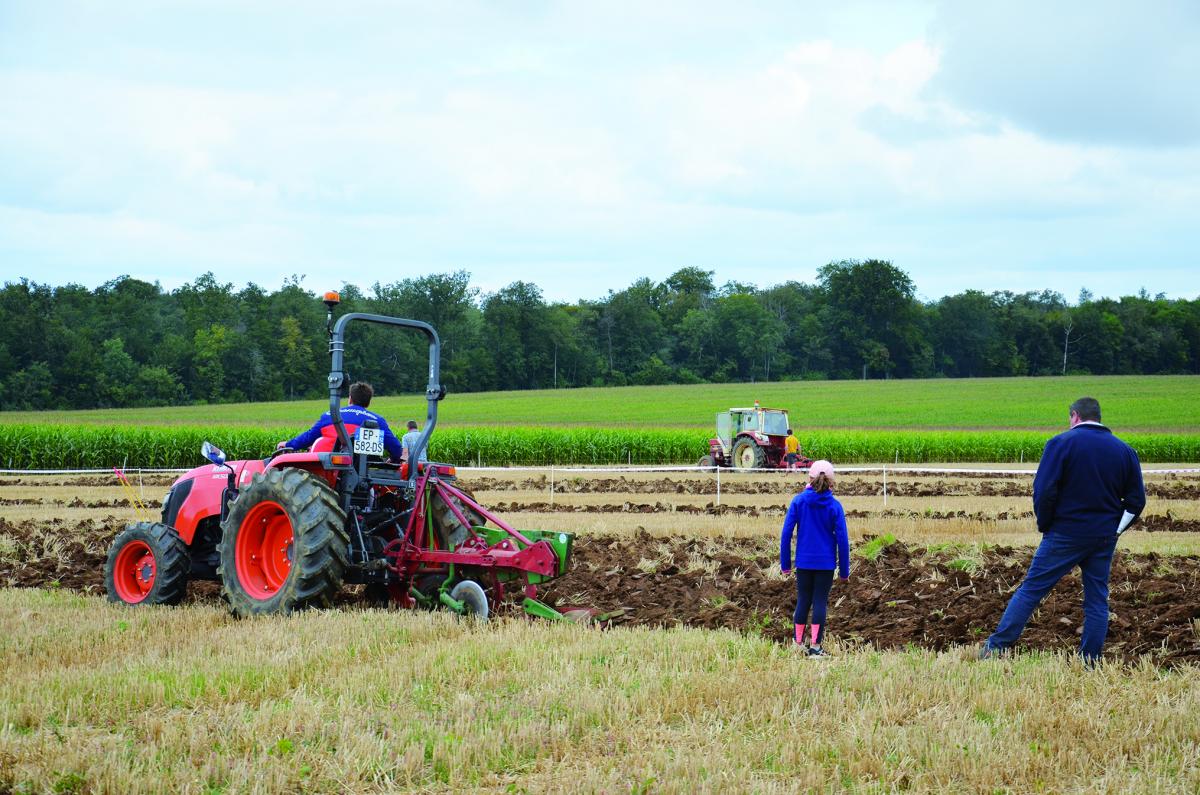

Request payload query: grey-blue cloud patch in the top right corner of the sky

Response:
[931,0,1200,145]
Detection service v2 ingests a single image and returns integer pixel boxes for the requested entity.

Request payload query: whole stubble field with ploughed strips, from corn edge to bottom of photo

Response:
[0,472,1200,793]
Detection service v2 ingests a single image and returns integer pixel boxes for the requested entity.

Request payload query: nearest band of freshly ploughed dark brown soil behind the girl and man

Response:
[0,516,1200,664]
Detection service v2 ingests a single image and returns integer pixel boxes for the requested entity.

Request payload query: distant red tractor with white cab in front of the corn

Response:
[697,402,812,470]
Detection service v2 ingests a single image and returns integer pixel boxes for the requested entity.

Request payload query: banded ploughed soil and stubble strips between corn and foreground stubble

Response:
[0,472,1200,664]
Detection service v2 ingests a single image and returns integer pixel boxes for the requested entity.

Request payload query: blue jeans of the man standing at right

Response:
[988,532,1117,662]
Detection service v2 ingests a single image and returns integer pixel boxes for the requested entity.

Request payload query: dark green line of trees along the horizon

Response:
[0,259,1200,410]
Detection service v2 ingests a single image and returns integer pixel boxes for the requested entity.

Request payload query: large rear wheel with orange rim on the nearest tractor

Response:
[217,467,349,616]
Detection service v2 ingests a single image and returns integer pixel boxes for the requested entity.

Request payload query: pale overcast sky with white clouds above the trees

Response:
[0,0,1200,300]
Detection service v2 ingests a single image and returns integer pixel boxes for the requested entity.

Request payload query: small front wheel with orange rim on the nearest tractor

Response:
[104,521,192,604]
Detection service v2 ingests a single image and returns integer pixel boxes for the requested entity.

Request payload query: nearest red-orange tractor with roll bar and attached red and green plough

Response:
[104,293,592,618]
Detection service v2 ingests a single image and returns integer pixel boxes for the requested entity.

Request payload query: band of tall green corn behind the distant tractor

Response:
[0,424,1200,470]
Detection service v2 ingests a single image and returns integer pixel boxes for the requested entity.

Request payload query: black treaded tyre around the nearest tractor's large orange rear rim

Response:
[217,467,350,616]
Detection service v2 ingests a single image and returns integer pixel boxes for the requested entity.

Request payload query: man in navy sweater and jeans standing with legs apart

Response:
[979,398,1146,663]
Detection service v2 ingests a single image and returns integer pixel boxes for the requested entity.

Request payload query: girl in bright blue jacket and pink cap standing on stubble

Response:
[779,461,850,657]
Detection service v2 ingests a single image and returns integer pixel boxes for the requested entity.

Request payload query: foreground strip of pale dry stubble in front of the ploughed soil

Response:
[0,590,1200,793]
